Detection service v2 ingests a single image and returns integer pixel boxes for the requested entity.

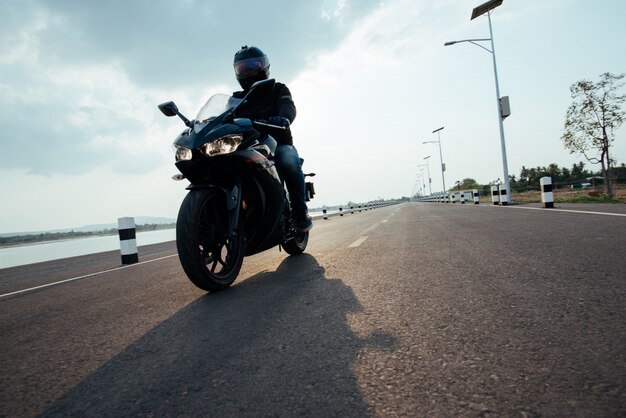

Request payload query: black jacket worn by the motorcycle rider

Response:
[233,82,296,145]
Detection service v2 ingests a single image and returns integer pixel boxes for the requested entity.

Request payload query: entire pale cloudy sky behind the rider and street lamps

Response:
[0,0,626,233]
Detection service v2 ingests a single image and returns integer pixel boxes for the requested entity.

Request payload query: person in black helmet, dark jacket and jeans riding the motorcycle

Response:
[233,46,313,231]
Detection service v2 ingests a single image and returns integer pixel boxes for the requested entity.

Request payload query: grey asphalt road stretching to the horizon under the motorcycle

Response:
[0,203,626,417]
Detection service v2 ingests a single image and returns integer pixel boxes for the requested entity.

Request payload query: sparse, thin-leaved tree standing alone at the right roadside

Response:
[561,73,626,197]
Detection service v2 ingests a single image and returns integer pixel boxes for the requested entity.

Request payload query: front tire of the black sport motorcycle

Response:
[176,189,245,292]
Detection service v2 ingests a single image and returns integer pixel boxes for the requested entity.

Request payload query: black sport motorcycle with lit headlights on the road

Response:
[158,79,315,292]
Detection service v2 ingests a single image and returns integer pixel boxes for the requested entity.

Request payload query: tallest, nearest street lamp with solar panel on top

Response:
[444,0,511,205]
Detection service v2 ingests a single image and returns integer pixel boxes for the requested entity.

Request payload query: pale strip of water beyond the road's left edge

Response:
[0,229,176,269]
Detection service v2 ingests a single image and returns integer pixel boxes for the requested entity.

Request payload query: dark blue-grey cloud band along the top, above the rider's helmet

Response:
[9,0,377,87]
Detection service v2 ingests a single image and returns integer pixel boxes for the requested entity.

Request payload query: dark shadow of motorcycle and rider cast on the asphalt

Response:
[43,254,395,417]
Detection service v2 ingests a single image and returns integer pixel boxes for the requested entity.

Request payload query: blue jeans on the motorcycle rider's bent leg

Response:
[274,145,306,210]
